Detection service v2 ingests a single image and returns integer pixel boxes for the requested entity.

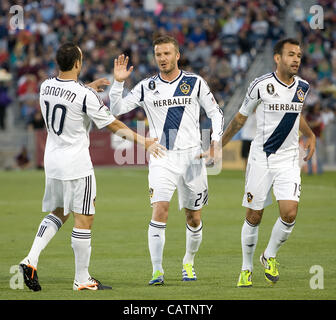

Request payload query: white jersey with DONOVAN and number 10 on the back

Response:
[40,78,115,180]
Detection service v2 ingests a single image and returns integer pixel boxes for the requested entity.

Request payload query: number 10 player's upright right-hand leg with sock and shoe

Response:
[71,213,112,291]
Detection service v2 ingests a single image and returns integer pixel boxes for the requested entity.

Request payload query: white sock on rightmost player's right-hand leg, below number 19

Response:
[264,217,295,259]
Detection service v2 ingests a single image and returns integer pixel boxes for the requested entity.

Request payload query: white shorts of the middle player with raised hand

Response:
[148,148,208,210]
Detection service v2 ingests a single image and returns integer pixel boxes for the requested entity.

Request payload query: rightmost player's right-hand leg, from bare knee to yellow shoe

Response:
[260,200,298,283]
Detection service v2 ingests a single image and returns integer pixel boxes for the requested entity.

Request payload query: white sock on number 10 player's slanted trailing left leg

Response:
[27,213,63,268]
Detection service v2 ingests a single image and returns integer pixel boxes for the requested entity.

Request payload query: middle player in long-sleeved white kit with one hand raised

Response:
[110,36,224,285]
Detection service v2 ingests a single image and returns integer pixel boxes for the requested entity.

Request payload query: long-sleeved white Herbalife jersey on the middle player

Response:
[110,70,224,150]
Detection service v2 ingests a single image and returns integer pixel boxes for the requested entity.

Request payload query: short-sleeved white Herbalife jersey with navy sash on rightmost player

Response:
[239,72,309,168]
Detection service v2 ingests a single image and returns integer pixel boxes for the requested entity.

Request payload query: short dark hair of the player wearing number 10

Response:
[56,42,81,71]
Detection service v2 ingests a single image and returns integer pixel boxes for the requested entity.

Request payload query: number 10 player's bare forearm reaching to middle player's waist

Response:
[107,120,167,158]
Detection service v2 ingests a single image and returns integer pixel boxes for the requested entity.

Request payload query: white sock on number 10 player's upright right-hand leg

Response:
[71,228,91,283]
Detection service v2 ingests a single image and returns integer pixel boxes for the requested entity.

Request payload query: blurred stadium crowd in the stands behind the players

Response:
[0,0,336,155]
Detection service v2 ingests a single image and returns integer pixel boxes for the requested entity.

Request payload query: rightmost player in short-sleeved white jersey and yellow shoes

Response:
[222,38,315,287]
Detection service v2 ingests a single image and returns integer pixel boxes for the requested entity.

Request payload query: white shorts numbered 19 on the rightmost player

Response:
[242,161,301,210]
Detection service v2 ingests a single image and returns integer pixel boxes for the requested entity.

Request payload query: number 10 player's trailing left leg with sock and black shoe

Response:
[20,208,69,291]
